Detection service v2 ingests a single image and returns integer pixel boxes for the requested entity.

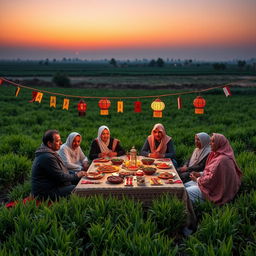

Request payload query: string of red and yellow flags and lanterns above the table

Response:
[0,77,249,118]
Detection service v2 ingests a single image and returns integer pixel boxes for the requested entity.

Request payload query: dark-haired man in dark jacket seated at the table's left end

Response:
[32,130,86,200]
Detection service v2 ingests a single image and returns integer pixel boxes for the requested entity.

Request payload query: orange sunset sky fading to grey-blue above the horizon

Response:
[0,0,256,60]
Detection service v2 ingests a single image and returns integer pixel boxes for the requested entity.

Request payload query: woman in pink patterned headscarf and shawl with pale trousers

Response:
[185,133,242,205]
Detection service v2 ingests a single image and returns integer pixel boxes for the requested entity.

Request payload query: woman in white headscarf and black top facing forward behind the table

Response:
[89,125,125,160]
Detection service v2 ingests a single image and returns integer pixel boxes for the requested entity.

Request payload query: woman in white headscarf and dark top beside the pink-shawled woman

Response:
[178,132,211,182]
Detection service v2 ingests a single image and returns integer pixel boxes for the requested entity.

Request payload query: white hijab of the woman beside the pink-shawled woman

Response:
[188,132,211,167]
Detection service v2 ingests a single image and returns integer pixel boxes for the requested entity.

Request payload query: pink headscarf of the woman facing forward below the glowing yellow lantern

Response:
[148,124,172,154]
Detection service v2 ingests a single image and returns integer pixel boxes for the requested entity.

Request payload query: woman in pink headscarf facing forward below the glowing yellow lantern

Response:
[140,124,177,165]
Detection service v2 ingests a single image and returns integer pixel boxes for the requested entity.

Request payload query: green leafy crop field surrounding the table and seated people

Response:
[0,84,256,255]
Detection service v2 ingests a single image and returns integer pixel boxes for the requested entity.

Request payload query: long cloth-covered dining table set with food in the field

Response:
[73,156,195,225]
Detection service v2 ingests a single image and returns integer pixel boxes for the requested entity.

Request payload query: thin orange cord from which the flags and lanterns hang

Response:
[0,77,255,99]
